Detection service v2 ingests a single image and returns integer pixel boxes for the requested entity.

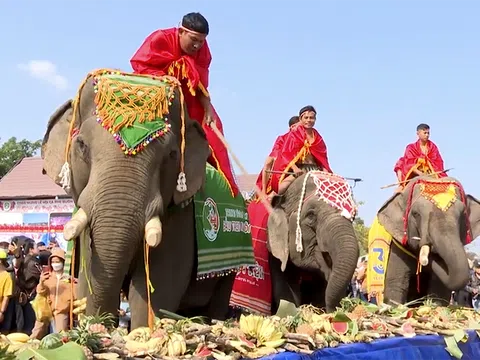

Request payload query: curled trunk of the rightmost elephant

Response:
[431,235,469,291]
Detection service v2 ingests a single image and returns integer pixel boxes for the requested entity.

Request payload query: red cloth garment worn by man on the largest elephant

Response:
[130,28,238,196]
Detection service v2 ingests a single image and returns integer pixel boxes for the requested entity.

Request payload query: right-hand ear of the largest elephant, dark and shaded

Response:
[173,119,210,204]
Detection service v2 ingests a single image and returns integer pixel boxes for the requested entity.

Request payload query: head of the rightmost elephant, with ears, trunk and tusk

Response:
[378,177,480,290]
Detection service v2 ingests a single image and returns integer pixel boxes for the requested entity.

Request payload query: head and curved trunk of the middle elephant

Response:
[268,175,359,311]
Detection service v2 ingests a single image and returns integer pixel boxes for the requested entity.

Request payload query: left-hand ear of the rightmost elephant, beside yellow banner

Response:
[377,193,405,239]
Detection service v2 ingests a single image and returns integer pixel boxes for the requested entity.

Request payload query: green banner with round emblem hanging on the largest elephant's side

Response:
[195,164,255,279]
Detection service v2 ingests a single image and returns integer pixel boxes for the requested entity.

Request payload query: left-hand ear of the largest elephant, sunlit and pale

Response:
[42,100,73,185]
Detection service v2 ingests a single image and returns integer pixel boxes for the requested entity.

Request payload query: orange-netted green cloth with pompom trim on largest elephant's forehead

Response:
[94,72,175,155]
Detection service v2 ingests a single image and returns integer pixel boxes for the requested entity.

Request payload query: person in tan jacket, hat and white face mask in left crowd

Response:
[31,248,76,339]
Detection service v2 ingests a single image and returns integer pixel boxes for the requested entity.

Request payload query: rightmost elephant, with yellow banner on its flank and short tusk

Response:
[377,176,480,304]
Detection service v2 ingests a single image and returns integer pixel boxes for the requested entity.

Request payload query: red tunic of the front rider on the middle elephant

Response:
[271,126,332,193]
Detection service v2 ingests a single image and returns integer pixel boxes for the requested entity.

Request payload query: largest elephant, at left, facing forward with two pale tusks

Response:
[42,71,235,329]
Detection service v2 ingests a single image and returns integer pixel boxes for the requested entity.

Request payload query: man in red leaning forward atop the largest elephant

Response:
[130,13,238,196]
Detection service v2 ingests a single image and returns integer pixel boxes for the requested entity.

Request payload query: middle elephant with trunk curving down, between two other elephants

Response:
[267,173,359,313]
